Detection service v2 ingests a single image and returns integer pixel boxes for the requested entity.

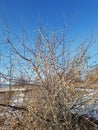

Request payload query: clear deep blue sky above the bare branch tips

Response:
[0,0,98,62]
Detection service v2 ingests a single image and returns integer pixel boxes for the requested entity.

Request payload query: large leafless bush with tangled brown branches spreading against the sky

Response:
[0,23,97,130]
